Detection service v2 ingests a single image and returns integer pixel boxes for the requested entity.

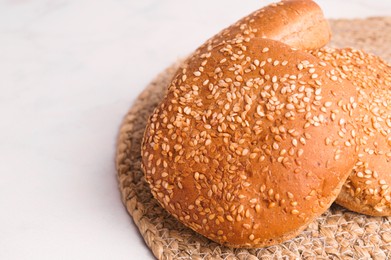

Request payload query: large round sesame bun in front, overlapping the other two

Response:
[142,1,357,247]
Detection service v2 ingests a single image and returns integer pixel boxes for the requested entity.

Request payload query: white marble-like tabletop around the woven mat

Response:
[0,0,391,259]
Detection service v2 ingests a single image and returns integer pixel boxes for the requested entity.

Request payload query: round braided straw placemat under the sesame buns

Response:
[116,17,391,260]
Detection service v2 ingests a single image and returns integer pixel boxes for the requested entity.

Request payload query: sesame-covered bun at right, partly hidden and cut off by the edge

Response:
[312,48,391,216]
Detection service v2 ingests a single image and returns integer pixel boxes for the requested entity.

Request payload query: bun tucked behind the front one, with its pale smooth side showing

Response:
[199,0,331,50]
